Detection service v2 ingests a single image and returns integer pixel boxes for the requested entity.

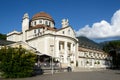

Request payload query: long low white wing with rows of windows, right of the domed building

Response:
[78,47,111,68]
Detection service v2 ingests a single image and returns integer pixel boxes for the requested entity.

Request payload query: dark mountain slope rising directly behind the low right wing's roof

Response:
[77,36,102,50]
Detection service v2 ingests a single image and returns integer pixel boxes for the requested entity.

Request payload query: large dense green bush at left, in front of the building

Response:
[0,47,36,78]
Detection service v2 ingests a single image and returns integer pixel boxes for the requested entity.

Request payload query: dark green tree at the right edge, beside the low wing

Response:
[103,40,120,68]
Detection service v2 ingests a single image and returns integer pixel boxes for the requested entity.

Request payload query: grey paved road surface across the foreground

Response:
[2,70,120,80]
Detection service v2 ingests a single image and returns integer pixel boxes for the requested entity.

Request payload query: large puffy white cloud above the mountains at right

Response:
[76,10,120,39]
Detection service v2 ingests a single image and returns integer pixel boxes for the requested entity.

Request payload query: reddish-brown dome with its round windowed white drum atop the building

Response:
[30,12,55,28]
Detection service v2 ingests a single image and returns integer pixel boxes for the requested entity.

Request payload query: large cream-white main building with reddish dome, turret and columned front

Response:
[7,12,110,67]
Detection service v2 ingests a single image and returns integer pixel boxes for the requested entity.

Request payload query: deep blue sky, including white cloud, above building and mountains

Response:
[0,0,120,42]
